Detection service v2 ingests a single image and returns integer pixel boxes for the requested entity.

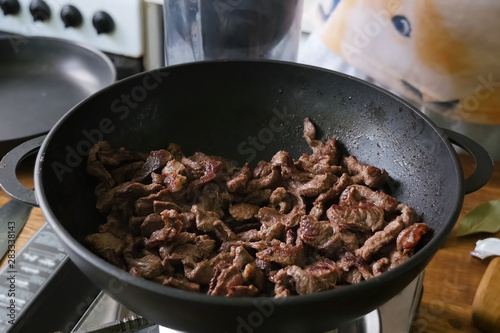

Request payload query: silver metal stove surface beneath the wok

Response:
[0,224,423,333]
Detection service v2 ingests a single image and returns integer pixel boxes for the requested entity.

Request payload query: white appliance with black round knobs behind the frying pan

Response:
[0,0,164,79]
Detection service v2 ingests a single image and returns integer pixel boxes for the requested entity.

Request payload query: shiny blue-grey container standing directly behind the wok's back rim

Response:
[164,0,303,65]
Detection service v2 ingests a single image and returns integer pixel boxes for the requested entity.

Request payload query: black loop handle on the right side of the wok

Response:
[442,128,493,194]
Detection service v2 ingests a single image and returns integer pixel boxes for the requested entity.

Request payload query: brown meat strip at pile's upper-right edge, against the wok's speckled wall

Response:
[342,156,389,188]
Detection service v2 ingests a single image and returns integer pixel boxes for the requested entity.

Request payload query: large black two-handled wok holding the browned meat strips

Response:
[0,61,493,332]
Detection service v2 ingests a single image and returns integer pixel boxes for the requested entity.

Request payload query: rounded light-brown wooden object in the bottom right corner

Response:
[472,257,500,332]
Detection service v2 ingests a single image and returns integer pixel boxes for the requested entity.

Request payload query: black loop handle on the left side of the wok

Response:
[0,135,45,206]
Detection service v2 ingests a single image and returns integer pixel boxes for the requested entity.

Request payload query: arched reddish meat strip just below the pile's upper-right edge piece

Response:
[339,185,398,213]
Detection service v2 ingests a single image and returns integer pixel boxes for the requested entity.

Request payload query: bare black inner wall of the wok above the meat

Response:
[37,62,463,278]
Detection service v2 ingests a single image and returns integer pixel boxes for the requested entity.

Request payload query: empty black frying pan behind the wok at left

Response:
[0,37,116,152]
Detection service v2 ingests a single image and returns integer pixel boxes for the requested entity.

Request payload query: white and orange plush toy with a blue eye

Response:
[320,0,500,125]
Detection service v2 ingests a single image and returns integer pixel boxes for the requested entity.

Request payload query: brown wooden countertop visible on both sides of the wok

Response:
[0,156,500,333]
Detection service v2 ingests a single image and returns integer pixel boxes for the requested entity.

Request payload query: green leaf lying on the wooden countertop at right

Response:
[457,200,500,236]
